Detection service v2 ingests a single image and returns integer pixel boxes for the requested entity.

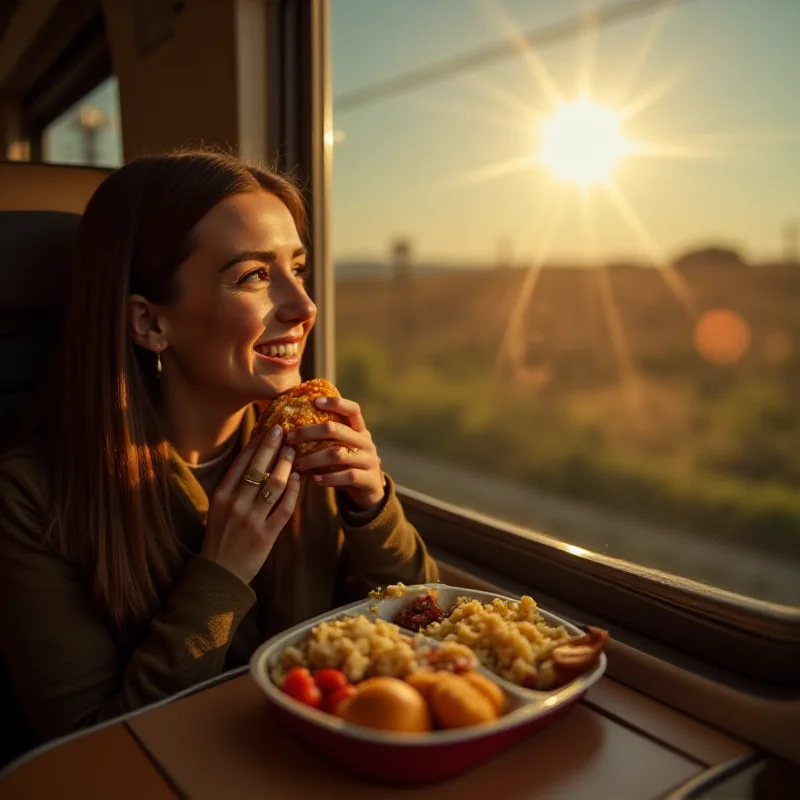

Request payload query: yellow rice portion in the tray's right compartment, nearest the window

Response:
[422,595,571,685]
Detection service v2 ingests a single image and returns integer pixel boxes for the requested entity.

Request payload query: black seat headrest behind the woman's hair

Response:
[0,211,81,313]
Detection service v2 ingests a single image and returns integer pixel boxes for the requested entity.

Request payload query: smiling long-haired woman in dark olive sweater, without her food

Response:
[0,152,437,738]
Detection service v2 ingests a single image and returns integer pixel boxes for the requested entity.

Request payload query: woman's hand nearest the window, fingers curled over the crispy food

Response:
[286,397,386,511]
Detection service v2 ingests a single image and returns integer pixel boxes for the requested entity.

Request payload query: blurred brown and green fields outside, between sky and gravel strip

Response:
[336,248,800,580]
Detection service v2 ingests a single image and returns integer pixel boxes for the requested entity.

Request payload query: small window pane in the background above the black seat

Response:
[42,76,122,167]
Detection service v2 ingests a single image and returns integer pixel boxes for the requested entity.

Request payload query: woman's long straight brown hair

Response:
[43,151,307,628]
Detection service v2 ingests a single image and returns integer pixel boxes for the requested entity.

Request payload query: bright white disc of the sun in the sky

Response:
[537,99,631,186]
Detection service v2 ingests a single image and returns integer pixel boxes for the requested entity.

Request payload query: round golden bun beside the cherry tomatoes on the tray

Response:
[336,677,432,733]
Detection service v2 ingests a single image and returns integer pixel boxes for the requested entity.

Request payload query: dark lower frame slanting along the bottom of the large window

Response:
[398,487,800,688]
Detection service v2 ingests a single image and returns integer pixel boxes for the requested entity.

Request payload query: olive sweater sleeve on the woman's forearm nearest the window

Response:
[337,475,439,597]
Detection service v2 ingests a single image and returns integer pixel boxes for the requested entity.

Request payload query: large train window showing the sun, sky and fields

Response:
[331,0,800,606]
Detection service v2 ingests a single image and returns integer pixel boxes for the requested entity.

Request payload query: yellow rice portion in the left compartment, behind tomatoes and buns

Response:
[270,615,474,686]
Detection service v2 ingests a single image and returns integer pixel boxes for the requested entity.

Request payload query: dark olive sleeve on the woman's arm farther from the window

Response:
[0,459,255,739]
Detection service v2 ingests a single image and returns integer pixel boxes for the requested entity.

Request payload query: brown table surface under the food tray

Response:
[0,675,749,800]
